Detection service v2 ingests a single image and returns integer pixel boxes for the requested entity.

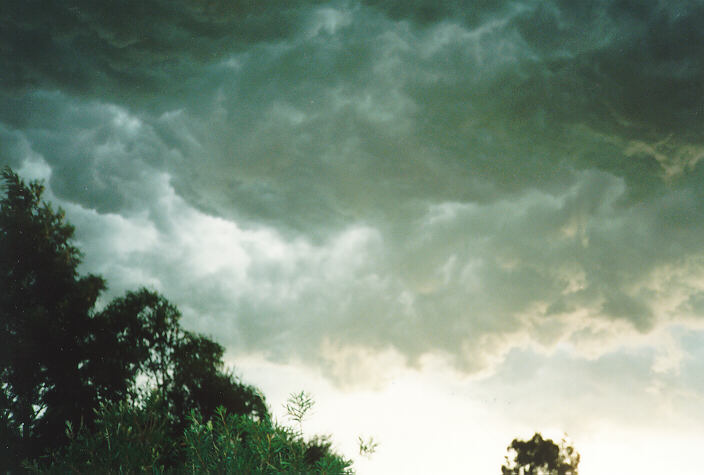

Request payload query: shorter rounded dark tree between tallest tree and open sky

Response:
[100,289,267,432]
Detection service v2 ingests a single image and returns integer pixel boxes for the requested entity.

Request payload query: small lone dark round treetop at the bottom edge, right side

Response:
[501,432,580,475]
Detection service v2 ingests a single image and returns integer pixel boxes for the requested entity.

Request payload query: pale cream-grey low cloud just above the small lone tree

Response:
[475,332,703,434]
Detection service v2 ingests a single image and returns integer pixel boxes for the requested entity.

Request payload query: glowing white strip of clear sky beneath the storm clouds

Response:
[236,357,704,475]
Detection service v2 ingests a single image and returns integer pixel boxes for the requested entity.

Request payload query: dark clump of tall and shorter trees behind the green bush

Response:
[0,168,267,471]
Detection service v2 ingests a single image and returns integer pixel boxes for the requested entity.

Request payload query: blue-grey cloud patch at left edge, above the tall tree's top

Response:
[0,91,171,212]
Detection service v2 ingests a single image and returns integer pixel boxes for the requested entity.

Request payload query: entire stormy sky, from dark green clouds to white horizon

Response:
[0,0,704,475]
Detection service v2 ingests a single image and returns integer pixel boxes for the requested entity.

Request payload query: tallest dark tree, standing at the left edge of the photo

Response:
[0,168,105,469]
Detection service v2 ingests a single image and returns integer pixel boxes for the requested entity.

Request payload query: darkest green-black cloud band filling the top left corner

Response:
[0,0,324,104]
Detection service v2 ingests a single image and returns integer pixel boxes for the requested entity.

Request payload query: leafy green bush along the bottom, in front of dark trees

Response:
[32,391,352,474]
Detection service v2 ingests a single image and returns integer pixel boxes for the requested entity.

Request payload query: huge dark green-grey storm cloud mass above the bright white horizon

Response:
[0,1,704,380]
